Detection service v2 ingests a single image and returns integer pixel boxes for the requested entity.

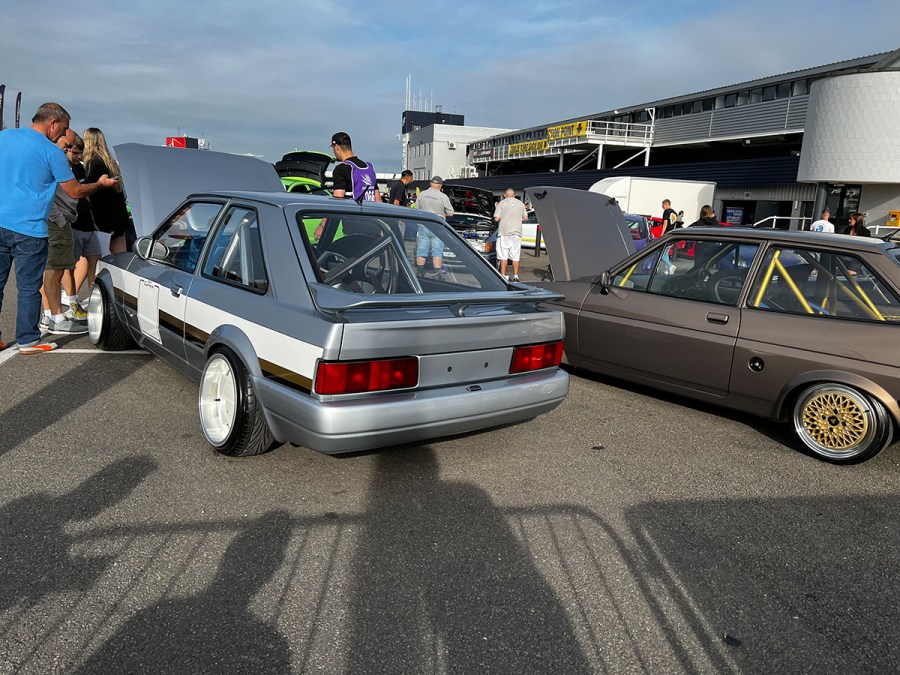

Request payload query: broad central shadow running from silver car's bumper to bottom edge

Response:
[348,450,591,674]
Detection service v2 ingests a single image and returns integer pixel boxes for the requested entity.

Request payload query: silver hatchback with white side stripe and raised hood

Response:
[88,144,568,455]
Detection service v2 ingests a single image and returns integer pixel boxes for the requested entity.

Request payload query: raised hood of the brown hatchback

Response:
[525,187,635,281]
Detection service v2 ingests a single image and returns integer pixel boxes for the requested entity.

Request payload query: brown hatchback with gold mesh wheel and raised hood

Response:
[529,187,900,464]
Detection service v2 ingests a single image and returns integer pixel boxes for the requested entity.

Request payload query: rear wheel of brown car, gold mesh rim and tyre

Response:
[792,382,894,464]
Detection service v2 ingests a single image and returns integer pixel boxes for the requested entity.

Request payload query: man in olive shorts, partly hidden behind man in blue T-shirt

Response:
[41,129,87,335]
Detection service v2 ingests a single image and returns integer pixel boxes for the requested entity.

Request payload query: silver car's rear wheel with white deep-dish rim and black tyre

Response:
[198,347,274,457]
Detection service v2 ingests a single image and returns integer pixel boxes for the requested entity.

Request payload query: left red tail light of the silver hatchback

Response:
[316,357,419,394]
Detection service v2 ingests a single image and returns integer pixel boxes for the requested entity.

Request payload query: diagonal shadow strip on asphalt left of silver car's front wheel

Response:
[0,354,149,455]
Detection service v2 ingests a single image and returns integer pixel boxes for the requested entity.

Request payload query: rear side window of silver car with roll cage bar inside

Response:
[203,206,269,292]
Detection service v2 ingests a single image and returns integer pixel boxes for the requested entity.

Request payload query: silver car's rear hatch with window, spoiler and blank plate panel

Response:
[292,205,563,388]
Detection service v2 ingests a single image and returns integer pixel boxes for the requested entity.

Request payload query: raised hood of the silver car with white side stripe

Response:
[115,143,284,237]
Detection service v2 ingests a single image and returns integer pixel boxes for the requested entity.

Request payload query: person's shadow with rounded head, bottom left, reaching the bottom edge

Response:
[77,511,291,674]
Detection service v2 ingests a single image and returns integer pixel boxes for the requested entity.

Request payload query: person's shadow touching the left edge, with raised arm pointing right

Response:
[0,457,157,611]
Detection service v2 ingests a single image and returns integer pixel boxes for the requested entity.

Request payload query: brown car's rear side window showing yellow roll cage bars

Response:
[748,247,900,323]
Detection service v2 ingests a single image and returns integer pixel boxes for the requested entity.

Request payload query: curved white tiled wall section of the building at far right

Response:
[797,70,900,184]
